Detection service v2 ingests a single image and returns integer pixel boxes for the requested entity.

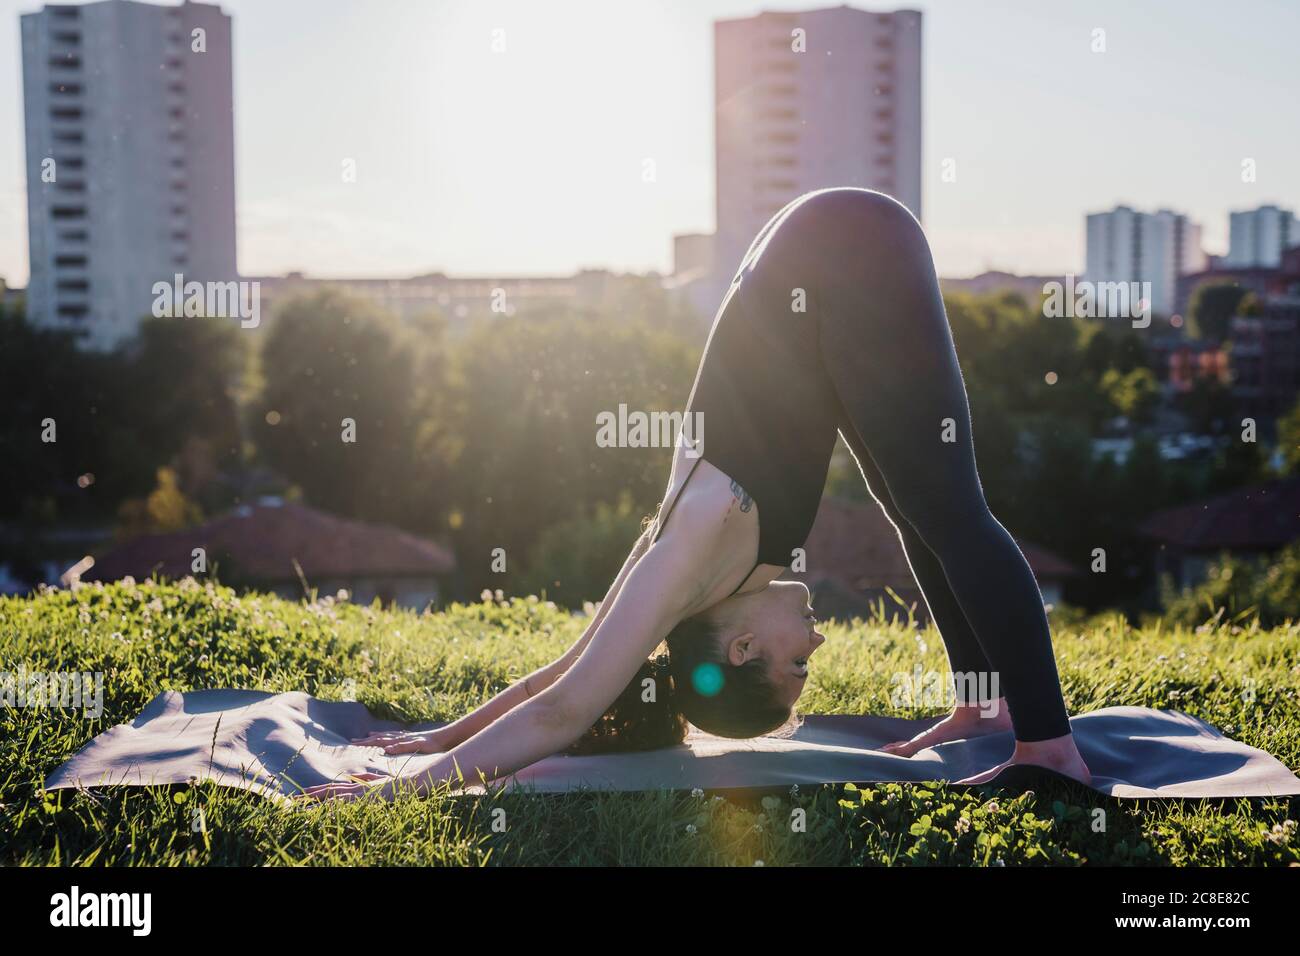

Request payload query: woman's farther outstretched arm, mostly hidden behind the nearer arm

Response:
[352,528,651,753]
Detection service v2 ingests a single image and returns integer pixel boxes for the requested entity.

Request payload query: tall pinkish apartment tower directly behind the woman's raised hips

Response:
[714,7,920,285]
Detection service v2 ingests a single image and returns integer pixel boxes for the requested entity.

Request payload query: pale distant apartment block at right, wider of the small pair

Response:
[1084,206,1206,315]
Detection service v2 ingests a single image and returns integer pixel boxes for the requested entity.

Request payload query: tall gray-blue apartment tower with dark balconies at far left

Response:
[22,0,238,349]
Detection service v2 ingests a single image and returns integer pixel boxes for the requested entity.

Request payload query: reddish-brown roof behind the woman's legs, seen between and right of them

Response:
[796,497,1076,591]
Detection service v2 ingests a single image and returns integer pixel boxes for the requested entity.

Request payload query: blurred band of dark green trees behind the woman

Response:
[0,282,1300,607]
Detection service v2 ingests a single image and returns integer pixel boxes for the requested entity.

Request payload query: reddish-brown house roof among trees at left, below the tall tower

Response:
[83,502,456,583]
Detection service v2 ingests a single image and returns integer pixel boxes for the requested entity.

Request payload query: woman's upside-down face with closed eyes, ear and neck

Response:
[712,581,826,706]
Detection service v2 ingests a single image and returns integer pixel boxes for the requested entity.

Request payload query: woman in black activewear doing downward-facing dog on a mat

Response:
[308,187,1089,797]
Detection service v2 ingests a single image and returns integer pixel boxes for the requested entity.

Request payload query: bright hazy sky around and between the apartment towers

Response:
[0,0,1300,285]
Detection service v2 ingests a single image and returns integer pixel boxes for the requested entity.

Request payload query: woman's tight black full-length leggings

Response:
[755,189,1070,741]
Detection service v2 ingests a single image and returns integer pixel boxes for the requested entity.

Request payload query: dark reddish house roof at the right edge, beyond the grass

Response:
[1140,477,1300,551]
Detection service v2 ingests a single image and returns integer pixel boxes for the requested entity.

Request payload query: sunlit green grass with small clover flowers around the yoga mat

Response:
[0,581,1300,866]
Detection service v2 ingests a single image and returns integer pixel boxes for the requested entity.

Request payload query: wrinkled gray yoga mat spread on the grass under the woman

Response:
[46,691,1300,799]
